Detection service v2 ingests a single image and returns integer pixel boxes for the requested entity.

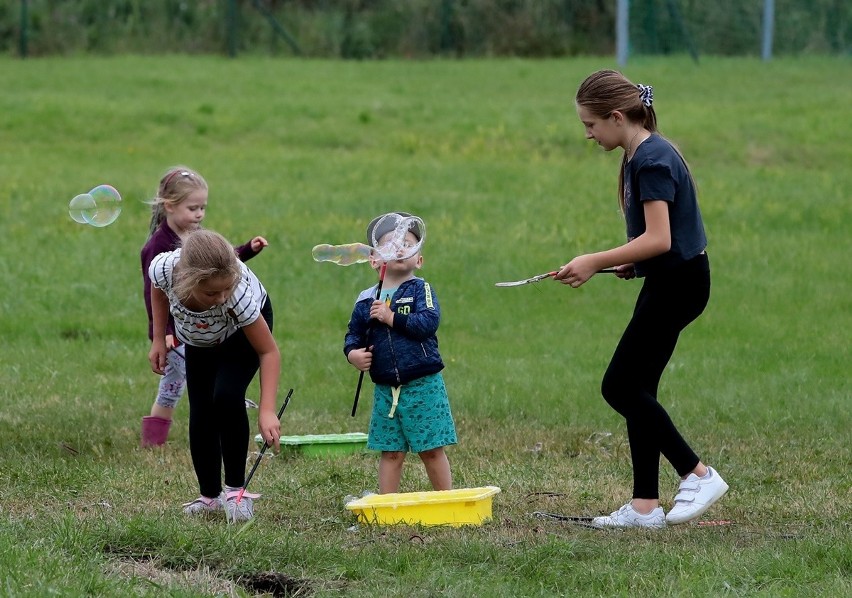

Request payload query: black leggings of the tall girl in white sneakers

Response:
[601,254,710,499]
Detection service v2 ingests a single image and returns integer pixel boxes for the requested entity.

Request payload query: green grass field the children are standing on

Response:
[0,56,852,598]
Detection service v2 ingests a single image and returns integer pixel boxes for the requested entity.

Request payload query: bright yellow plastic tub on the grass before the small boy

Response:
[346,486,500,527]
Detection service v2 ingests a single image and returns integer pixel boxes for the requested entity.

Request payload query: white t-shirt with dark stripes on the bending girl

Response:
[148,249,266,347]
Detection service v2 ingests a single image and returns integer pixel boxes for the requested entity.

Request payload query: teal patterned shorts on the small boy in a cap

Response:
[367,373,457,453]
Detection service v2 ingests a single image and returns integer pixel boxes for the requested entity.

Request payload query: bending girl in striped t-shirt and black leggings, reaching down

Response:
[148,229,281,520]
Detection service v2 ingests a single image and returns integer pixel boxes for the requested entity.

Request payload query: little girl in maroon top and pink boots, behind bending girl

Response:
[141,166,268,447]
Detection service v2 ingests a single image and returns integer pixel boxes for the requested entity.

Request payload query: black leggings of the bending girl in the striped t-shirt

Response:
[186,298,272,498]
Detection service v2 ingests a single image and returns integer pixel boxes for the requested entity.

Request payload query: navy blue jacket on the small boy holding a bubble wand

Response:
[343,277,444,386]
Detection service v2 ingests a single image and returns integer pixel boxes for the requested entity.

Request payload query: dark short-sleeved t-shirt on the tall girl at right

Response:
[624,134,707,276]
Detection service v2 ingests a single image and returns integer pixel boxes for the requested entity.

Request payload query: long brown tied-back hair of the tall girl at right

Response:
[574,70,695,212]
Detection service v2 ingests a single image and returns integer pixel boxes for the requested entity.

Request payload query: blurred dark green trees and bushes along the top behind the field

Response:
[0,0,852,59]
